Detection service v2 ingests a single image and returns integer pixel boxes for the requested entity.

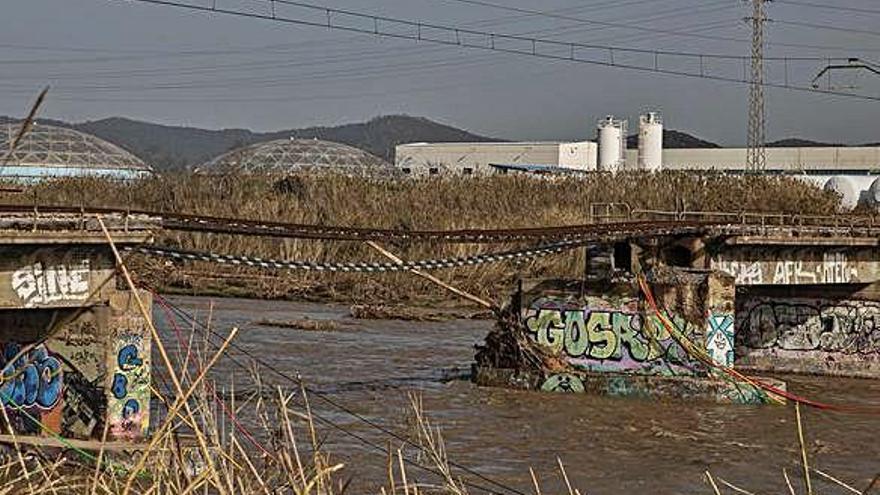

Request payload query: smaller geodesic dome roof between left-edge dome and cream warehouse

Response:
[204,138,396,175]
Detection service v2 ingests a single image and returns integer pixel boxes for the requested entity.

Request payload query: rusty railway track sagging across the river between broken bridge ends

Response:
[0,204,880,244]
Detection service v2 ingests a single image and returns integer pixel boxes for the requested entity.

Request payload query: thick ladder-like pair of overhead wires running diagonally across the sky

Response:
[105,0,880,101]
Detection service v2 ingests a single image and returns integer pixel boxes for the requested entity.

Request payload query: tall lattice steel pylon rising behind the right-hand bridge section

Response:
[746,0,770,172]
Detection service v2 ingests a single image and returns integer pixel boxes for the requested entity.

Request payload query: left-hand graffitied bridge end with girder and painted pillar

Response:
[0,216,151,441]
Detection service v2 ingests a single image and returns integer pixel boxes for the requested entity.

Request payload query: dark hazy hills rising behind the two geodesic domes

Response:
[0,115,499,170]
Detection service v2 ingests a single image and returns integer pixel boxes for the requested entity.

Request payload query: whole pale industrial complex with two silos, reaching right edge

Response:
[395,112,880,206]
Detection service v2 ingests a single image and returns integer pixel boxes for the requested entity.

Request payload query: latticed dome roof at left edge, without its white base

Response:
[0,123,152,175]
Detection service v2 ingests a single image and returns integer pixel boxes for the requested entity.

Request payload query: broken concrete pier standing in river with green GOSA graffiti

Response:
[474,267,785,403]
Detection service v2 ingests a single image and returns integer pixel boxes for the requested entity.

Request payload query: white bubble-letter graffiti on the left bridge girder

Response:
[12,254,89,307]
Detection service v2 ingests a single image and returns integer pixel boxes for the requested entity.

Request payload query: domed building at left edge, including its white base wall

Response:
[0,123,153,181]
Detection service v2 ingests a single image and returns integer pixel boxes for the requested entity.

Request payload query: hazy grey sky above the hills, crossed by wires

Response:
[0,0,880,145]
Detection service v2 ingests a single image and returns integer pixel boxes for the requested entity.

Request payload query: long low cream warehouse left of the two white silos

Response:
[394,141,598,175]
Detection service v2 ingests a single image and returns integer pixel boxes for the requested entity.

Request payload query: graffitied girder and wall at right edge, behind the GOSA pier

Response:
[641,228,880,378]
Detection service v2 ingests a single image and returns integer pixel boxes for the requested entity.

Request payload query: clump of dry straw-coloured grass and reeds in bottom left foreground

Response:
[0,328,342,494]
